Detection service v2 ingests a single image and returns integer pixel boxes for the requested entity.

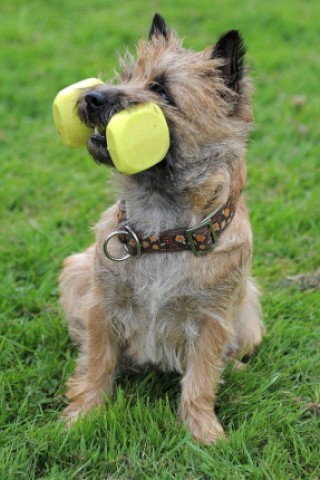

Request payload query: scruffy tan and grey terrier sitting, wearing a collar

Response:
[60,14,263,443]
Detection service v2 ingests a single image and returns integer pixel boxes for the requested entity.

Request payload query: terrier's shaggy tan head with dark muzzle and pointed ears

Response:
[78,14,251,204]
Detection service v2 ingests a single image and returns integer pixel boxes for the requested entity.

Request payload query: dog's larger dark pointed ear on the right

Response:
[212,30,246,92]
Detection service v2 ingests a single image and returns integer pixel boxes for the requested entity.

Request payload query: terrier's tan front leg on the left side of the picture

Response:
[63,297,121,423]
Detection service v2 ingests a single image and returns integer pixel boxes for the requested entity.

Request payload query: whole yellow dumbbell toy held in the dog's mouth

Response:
[53,78,170,175]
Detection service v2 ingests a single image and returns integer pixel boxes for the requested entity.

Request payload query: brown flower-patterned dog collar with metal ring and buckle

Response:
[103,200,235,262]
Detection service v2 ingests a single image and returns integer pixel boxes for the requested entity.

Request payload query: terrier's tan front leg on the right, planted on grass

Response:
[180,317,230,443]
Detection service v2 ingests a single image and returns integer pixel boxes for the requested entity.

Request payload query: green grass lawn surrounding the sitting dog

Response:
[0,0,320,480]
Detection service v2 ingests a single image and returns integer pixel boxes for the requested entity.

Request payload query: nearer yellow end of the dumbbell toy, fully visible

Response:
[106,102,170,175]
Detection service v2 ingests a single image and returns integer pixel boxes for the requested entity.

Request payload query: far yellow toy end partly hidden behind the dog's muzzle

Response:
[52,78,103,147]
